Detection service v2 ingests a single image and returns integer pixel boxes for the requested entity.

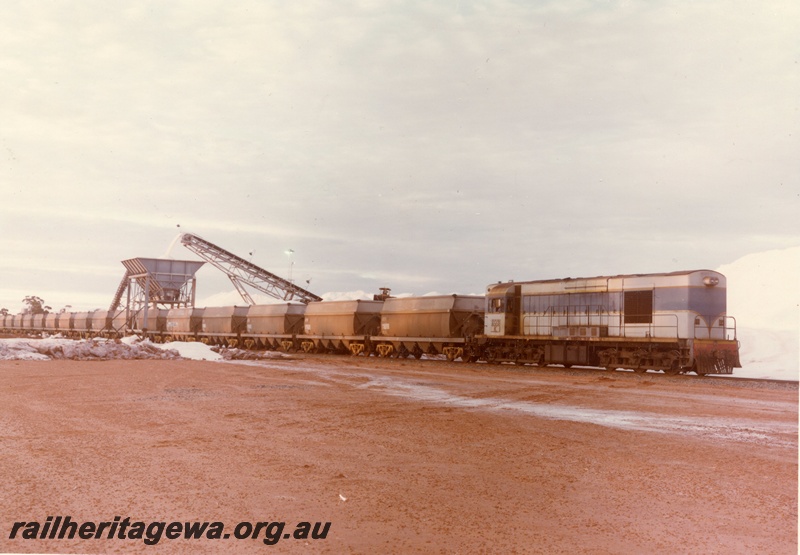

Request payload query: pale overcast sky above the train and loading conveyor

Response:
[0,0,800,311]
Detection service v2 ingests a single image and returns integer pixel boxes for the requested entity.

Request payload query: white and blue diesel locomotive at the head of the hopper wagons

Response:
[475,270,741,374]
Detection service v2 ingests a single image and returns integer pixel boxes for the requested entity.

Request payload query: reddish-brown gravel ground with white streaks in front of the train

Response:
[0,356,798,555]
